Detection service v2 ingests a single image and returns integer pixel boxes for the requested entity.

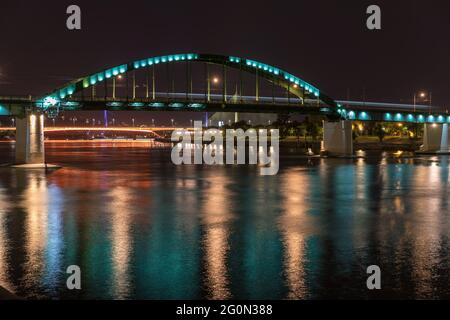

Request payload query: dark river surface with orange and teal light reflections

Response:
[0,142,450,299]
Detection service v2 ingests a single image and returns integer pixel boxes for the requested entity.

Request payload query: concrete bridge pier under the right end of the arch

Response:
[321,120,353,157]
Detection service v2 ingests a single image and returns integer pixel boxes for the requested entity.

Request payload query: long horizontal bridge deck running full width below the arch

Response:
[0,99,450,124]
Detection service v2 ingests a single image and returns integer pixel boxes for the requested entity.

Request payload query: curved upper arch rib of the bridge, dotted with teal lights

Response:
[41,53,338,108]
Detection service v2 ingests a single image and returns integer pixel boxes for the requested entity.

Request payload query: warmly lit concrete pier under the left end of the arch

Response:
[16,113,45,165]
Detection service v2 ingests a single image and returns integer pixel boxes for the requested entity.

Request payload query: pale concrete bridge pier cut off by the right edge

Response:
[419,123,450,154]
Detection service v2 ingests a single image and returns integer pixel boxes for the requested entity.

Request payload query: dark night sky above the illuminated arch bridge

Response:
[0,0,450,105]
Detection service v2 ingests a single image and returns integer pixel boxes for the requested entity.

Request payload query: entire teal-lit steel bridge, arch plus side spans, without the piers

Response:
[0,53,450,123]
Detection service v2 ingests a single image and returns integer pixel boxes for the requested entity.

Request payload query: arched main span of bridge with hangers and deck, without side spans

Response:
[36,53,340,118]
